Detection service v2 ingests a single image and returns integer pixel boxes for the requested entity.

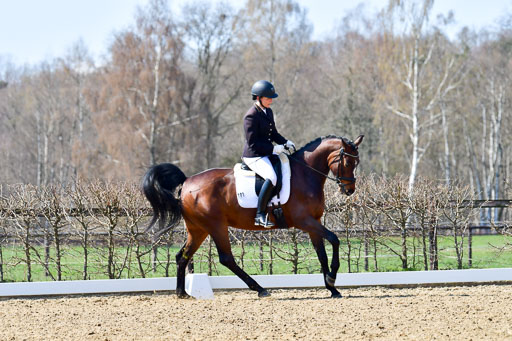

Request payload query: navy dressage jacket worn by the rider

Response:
[242,104,287,157]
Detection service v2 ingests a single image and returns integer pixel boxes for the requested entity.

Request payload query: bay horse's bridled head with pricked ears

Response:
[327,135,364,195]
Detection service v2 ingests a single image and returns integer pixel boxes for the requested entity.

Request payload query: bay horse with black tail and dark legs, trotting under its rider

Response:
[142,135,364,298]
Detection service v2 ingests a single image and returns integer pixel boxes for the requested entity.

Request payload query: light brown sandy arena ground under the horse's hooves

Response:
[0,285,512,340]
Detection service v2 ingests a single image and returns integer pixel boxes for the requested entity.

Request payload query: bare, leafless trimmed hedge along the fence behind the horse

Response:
[0,175,511,281]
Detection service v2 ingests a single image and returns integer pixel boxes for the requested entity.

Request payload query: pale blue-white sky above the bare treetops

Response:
[0,0,512,65]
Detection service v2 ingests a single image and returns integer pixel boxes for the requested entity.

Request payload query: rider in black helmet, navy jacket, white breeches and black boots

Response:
[242,80,295,227]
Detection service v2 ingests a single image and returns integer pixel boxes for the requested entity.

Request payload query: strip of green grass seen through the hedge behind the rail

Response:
[2,235,512,282]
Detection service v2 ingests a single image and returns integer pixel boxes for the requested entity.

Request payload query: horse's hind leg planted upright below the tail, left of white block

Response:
[176,224,208,298]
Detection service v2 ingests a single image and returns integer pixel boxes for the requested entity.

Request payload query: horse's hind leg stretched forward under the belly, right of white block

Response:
[210,227,270,297]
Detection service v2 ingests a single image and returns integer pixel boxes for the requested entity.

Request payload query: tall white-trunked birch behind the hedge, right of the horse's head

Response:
[387,0,461,191]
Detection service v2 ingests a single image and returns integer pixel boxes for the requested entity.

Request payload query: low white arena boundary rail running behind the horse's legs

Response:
[0,268,512,299]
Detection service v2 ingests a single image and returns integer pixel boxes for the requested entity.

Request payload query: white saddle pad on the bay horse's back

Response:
[233,153,291,208]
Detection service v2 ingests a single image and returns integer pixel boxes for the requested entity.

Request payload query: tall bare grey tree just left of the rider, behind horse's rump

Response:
[182,2,243,168]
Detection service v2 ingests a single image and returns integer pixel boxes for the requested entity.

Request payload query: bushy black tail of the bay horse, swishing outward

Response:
[142,163,187,237]
